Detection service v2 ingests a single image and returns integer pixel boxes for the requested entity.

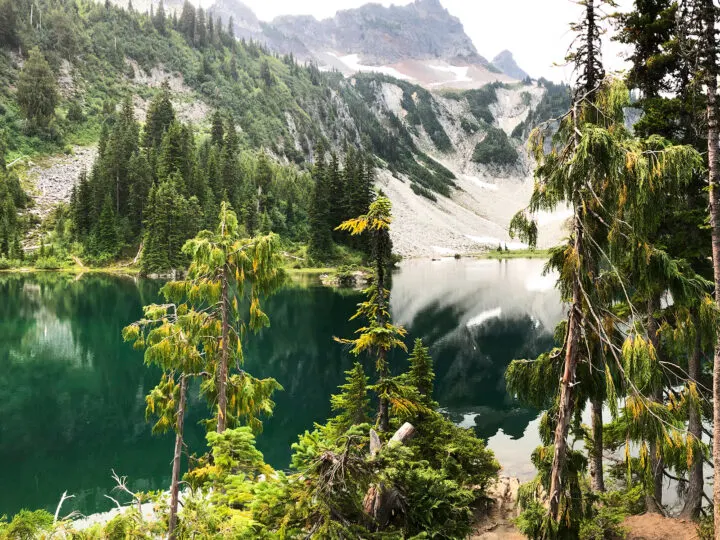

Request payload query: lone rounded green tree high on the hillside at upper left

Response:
[17,47,58,129]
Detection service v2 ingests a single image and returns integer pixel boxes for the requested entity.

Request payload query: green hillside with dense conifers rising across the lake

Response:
[0,0,566,271]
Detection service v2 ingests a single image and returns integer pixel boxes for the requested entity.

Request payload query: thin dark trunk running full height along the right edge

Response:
[702,0,720,539]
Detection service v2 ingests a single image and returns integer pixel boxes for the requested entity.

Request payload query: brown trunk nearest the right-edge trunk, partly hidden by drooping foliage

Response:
[680,309,704,519]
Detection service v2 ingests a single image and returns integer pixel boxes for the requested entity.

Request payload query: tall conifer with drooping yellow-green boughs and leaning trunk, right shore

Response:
[512,71,699,540]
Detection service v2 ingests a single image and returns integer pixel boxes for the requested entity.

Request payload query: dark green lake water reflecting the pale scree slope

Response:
[0,259,564,515]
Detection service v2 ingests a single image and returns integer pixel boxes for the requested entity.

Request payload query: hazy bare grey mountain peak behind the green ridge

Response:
[272,0,487,65]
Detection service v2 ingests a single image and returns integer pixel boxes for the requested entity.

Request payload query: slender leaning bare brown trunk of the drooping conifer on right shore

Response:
[549,217,583,520]
